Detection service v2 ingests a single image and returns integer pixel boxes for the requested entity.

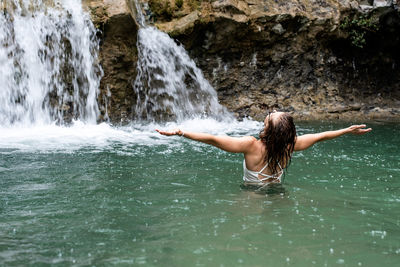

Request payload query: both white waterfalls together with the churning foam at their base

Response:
[0,0,258,154]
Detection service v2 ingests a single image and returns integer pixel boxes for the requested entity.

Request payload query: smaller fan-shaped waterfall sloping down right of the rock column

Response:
[133,0,232,121]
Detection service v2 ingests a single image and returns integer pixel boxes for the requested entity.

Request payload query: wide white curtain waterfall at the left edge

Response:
[0,0,102,126]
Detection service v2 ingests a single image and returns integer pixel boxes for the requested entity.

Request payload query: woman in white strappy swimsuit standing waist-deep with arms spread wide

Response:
[156,111,371,185]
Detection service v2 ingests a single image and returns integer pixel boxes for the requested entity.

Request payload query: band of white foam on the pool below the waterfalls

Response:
[0,119,262,153]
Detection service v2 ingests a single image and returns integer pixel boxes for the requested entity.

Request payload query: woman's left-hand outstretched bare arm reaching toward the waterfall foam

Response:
[156,129,256,153]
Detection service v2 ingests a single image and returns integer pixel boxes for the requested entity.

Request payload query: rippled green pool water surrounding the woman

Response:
[0,123,400,266]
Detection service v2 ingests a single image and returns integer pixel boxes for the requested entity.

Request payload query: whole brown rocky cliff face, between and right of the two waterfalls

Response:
[88,0,400,121]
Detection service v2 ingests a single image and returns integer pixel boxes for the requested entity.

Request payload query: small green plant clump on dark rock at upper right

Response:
[340,15,379,48]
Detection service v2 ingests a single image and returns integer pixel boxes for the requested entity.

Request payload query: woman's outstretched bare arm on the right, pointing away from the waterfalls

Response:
[294,124,372,151]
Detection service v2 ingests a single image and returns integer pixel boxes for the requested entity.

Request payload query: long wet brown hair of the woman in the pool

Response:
[259,113,296,174]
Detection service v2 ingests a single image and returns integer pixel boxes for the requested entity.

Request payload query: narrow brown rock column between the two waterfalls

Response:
[84,0,138,123]
